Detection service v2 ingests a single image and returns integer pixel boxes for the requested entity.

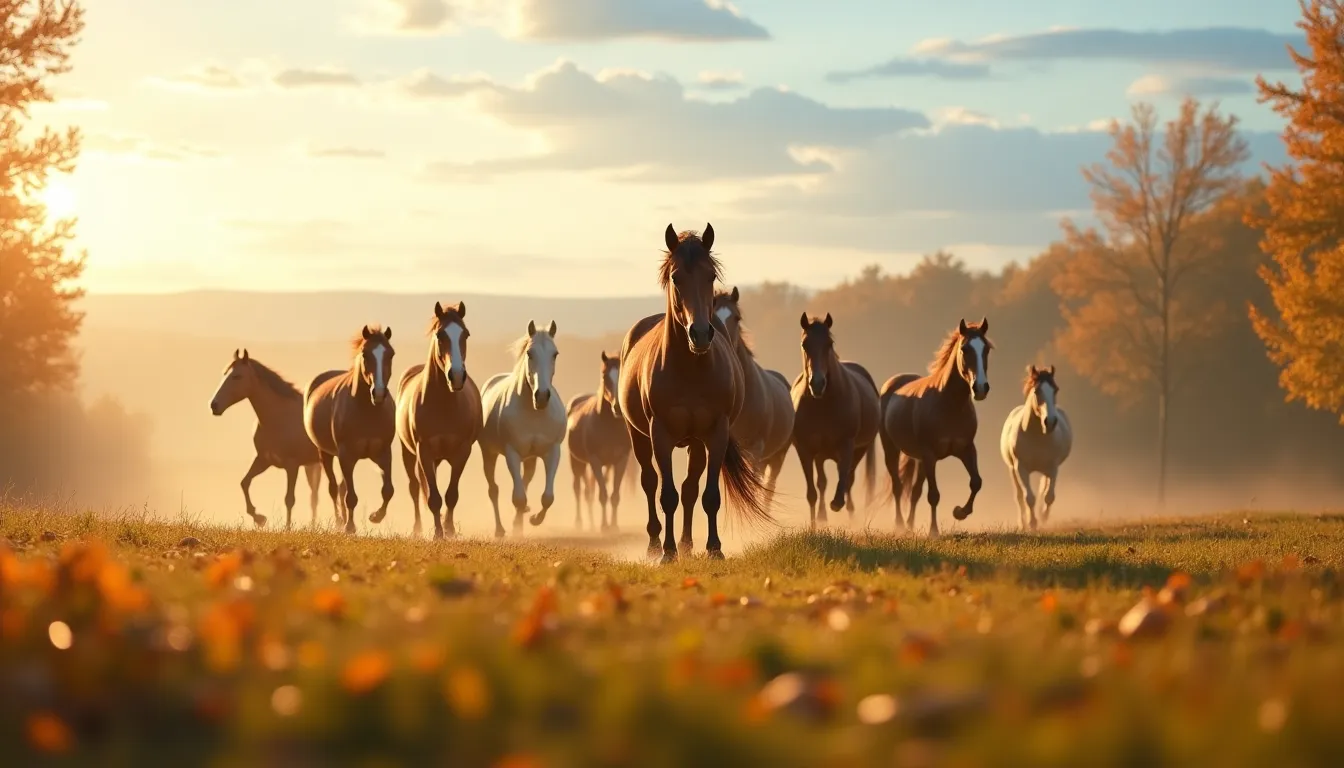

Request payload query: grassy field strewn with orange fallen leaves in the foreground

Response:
[0,503,1344,768]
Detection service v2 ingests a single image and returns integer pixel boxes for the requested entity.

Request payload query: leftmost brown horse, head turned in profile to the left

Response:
[210,350,321,529]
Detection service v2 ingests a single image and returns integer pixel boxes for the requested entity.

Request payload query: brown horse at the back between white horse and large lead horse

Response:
[564,351,630,531]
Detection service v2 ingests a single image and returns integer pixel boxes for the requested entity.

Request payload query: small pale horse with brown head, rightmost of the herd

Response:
[999,366,1074,530]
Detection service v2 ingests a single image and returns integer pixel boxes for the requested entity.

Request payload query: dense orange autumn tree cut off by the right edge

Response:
[1251,0,1344,421]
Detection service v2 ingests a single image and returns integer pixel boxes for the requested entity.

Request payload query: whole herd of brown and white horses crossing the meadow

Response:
[210,225,1073,562]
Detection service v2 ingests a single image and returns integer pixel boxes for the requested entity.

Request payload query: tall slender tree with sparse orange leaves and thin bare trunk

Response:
[1052,98,1250,506]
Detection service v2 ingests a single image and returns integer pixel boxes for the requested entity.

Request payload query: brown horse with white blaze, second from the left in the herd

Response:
[304,325,396,534]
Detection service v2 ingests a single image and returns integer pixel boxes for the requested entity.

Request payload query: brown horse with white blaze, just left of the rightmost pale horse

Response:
[880,319,995,535]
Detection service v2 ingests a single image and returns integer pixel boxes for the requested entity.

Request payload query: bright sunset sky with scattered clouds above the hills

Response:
[34,0,1302,296]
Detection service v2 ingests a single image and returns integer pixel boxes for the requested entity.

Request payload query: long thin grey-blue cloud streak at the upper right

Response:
[915,27,1305,71]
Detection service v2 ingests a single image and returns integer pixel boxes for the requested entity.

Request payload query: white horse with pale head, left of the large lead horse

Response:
[480,320,566,537]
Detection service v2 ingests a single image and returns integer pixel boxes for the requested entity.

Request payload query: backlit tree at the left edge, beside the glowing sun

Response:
[0,0,85,403]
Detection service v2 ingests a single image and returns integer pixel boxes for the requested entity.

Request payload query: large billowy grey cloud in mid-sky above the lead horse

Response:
[427,61,929,183]
